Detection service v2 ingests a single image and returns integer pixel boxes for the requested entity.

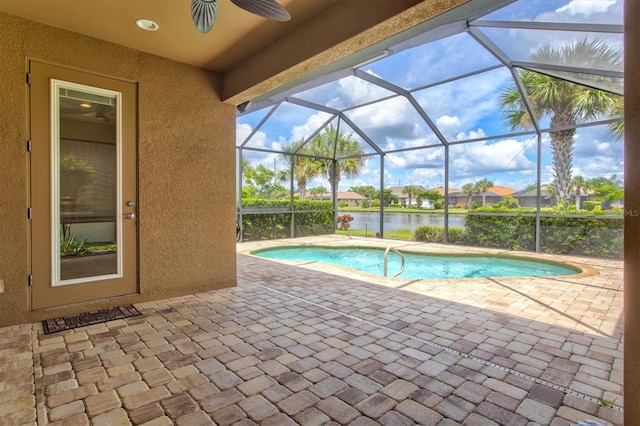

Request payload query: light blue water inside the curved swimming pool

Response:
[252,246,581,279]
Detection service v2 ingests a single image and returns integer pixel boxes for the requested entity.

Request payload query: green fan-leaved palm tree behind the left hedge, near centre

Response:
[309,124,365,194]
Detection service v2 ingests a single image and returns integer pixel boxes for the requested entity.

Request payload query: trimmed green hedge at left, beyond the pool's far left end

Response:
[242,198,334,241]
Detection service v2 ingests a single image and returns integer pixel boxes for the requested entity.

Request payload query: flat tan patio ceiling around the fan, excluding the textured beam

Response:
[0,0,337,72]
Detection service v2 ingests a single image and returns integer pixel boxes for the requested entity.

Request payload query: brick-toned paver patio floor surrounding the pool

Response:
[0,236,622,426]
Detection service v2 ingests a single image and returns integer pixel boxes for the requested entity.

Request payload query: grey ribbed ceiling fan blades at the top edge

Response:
[191,0,291,34]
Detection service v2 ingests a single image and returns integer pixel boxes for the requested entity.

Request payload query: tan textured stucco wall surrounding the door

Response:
[0,13,236,326]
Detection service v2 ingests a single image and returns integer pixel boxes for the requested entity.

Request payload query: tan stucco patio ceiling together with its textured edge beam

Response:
[0,0,480,105]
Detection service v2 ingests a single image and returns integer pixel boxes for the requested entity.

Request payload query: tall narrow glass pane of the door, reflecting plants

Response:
[53,82,119,284]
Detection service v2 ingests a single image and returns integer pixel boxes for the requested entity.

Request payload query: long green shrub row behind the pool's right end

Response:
[414,208,623,259]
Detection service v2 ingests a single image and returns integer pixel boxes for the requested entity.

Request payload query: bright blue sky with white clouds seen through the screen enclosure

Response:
[236,0,623,191]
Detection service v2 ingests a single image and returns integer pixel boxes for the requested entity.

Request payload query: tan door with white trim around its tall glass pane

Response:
[27,59,139,310]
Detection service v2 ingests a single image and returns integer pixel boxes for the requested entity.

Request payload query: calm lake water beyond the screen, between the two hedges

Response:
[338,212,464,232]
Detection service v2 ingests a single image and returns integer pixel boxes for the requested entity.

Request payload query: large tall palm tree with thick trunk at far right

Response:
[498,37,622,204]
